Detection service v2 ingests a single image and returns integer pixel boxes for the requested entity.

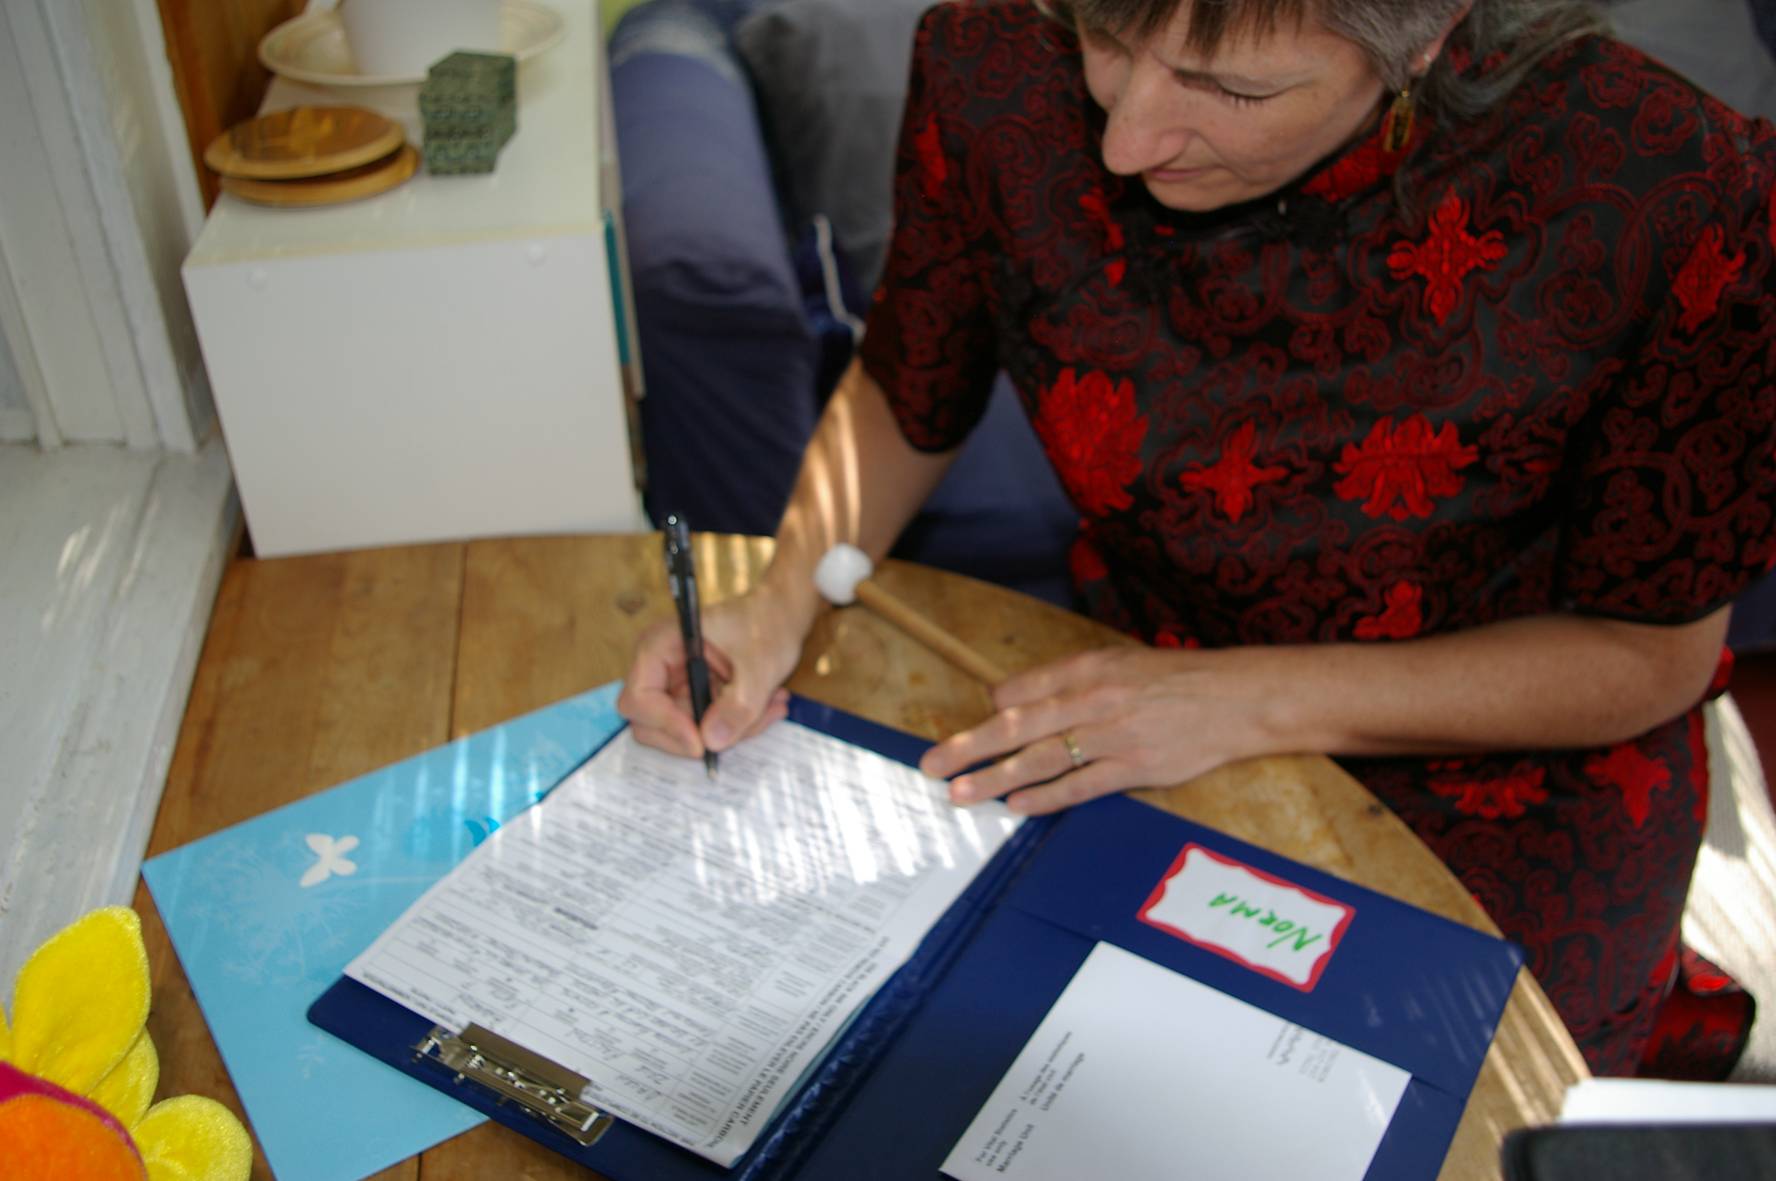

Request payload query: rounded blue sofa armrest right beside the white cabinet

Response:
[611,0,819,533]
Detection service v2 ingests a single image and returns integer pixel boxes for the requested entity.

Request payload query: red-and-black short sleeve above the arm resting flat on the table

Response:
[1556,115,1776,623]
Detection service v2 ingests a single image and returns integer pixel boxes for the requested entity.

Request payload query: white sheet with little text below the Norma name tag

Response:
[943,943,1410,1181]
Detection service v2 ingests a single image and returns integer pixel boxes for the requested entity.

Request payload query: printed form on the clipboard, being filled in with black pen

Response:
[346,723,1018,1165]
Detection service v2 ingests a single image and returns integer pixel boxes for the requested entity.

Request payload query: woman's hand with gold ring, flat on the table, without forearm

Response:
[920,648,1268,815]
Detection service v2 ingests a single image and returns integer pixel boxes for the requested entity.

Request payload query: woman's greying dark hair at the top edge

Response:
[1035,0,1607,123]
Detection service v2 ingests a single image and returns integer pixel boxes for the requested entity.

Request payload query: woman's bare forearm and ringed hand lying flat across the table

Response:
[920,607,1730,813]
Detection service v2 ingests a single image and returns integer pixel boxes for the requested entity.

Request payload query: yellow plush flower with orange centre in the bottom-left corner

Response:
[0,906,252,1181]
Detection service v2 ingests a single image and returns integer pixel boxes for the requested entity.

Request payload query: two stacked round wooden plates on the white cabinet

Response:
[204,107,419,206]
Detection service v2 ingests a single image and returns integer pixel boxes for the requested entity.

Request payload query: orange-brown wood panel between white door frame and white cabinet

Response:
[156,0,307,210]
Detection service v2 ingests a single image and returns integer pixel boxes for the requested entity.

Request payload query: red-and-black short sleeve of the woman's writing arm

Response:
[858,5,998,451]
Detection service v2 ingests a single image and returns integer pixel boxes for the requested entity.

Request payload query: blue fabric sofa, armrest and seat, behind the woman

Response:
[609,0,1074,604]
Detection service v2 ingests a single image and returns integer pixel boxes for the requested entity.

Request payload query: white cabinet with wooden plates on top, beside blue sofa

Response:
[185,0,646,556]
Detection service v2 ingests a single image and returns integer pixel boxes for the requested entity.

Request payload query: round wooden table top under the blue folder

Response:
[135,535,1586,1181]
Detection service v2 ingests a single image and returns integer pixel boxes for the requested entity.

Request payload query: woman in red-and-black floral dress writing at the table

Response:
[622,0,1776,1074]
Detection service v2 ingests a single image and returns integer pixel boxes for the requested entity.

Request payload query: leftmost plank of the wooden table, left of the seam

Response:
[135,545,462,1181]
